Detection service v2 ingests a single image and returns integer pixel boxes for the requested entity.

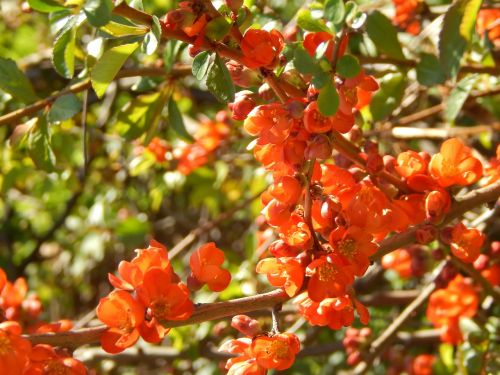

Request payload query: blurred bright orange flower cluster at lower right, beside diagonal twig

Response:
[427,274,479,344]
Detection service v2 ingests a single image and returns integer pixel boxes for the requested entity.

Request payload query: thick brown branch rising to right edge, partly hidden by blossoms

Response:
[370,181,500,261]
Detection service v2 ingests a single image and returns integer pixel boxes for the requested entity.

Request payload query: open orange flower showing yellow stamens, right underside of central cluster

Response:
[327,226,378,276]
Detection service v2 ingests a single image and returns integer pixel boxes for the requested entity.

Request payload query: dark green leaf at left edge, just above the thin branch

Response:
[0,57,37,103]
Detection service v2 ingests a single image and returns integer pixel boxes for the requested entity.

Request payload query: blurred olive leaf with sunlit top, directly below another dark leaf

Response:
[370,73,406,121]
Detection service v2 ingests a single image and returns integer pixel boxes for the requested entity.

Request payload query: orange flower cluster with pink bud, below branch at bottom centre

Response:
[219,316,300,375]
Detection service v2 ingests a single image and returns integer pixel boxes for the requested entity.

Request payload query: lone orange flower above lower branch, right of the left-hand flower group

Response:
[189,242,231,292]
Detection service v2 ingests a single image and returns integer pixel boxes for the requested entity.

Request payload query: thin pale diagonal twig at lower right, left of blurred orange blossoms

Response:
[354,261,447,375]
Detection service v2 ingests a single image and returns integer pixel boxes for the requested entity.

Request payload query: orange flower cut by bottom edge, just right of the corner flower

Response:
[24,344,87,375]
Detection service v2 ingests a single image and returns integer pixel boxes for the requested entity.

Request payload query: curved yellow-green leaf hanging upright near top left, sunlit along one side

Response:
[52,17,77,78]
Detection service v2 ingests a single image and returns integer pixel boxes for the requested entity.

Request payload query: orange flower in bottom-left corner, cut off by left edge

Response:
[0,321,31,375]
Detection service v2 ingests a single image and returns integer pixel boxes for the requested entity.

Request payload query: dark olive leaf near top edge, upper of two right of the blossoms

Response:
[366,10,405,59]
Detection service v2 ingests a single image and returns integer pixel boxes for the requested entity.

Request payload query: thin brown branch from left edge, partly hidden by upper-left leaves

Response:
[0,65,191,126]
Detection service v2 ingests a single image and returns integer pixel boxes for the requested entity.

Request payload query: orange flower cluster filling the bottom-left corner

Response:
[0,268,88,375]
